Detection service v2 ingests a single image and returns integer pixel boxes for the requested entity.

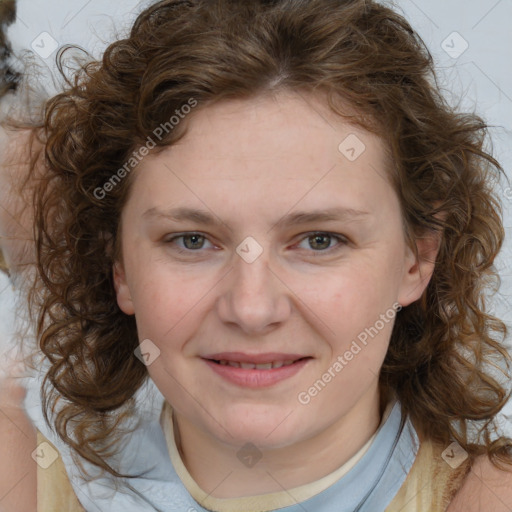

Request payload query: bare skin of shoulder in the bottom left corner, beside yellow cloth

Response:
[0,377,37,512]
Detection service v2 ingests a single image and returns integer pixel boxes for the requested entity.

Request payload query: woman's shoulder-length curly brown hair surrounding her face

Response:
[27,0,512,475]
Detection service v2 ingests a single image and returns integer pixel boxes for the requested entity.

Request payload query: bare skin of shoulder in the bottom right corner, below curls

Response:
[447,455,512,512]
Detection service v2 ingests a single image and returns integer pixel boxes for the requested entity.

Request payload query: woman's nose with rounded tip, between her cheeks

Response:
[217,248,291,335]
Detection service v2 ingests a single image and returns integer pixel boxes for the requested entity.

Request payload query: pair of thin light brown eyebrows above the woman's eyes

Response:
[142,207,372,230]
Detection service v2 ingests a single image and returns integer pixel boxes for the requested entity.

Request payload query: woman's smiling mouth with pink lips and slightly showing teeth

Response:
[202,352,313,388]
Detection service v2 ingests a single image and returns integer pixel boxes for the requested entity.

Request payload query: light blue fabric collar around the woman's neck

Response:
[25,362,419,512]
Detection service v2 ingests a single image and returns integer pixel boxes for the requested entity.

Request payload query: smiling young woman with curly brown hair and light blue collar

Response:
[1,0,511,512]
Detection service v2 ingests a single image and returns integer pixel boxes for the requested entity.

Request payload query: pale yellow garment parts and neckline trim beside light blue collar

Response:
[37,403,470,512]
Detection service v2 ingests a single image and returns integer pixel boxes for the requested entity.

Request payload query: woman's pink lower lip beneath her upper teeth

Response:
[204,358,310,389]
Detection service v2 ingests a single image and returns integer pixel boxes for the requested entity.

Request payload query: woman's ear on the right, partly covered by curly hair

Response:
[397,226,442,307]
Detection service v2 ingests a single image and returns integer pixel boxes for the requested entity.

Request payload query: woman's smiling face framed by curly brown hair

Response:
[115,93,435,448]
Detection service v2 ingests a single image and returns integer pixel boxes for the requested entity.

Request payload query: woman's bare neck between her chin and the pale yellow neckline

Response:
[174,390,382,498]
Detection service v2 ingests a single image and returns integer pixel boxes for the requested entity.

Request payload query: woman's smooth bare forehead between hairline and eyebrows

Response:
[133,92,393,220]
